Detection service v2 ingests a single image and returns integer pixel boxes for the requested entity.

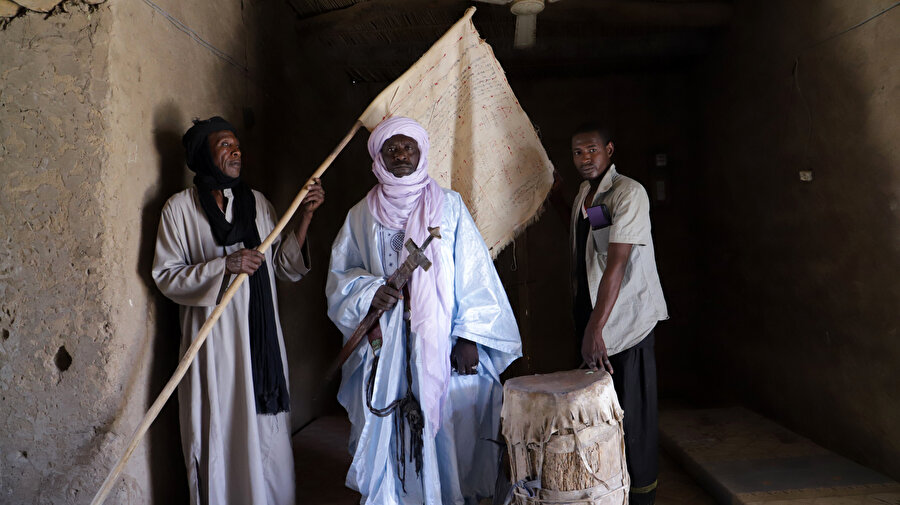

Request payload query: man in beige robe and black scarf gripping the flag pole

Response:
[153,117,324,505]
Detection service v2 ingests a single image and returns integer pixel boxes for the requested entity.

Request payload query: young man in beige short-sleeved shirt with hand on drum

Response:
[571,124,669,505]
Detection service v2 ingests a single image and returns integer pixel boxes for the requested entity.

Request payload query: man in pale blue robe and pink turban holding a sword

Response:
[326,118,521,505]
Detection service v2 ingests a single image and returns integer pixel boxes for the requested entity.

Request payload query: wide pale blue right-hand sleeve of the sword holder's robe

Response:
[448,193,522,375]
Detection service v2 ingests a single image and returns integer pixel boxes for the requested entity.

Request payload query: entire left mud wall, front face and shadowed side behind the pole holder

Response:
[0,0,303,504]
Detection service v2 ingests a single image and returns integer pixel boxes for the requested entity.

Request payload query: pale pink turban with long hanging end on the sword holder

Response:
[366,117,453,436]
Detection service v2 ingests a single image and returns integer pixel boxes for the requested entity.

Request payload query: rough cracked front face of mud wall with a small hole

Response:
[0,4,123,504]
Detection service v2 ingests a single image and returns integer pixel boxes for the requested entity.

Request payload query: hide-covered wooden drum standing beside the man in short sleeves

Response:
[500,370,630,505]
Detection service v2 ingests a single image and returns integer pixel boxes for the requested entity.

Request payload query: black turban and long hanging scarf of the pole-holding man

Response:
[181,116,291,414]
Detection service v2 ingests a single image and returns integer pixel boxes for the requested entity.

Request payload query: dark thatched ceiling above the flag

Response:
[286,0,731,82]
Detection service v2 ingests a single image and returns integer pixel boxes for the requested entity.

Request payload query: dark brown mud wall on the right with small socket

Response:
[702,1,900,478]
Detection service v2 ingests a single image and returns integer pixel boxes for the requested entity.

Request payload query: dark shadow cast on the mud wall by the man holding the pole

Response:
[137,103,188,505]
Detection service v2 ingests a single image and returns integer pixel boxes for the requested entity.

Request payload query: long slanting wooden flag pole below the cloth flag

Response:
[91,120,362,505]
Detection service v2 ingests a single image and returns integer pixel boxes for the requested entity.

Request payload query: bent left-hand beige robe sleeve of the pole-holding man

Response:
[153,202,225,307]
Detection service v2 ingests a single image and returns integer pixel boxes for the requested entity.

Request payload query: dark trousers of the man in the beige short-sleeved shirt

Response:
[609,331,659,505]
